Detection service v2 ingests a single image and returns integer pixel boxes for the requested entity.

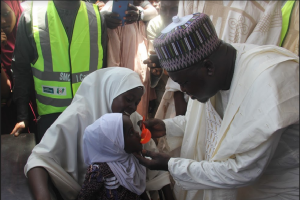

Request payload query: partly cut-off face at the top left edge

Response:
[1,1,16,34]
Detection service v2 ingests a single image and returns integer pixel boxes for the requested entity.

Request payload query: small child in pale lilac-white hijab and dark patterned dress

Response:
[78,113,148,200]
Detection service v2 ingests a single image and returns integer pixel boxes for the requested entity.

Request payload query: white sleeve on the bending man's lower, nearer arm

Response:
[168,129,284,190]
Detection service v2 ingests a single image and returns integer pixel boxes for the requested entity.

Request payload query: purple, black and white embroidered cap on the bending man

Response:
[153,13,221,72]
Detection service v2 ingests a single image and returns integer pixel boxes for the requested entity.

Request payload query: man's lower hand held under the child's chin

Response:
[133,149,171,171]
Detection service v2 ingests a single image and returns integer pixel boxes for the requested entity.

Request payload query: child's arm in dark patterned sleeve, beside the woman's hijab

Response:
[77,165,104,200]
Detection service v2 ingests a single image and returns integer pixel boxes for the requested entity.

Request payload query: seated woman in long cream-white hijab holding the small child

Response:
[24,67,170,200]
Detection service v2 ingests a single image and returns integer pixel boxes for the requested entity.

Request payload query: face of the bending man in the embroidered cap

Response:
[169,62,219,103]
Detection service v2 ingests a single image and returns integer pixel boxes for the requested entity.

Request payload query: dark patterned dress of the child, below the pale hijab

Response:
[77,163,140,200]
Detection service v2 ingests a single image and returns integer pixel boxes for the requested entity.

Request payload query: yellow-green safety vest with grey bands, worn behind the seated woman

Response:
[31,1,103,115]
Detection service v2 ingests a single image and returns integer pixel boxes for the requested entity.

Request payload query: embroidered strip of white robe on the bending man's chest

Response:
[205,100,222,160]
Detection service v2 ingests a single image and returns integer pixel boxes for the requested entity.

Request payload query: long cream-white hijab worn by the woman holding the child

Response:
[24,67,144,199]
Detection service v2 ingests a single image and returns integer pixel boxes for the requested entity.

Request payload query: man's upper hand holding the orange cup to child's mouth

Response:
[138,118,166,138]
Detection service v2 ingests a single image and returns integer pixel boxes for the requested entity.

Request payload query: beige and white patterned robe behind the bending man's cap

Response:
[178,0,284,45]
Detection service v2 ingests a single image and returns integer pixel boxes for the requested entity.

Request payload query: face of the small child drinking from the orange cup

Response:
[123,115,143,153]
